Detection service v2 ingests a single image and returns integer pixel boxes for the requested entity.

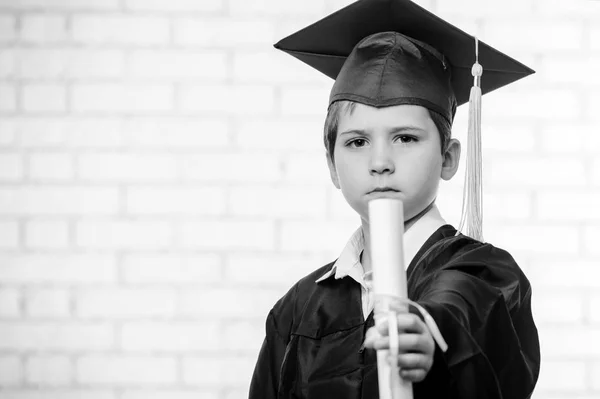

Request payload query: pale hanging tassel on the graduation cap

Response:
[457,38,483,241]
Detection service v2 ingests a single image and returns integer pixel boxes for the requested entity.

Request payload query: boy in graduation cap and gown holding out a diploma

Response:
[250,0,540,399]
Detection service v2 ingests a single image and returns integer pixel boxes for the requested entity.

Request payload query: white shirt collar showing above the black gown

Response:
[315,204,446,287]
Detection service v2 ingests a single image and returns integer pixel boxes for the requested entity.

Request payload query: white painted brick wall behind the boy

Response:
[0,0,600,399]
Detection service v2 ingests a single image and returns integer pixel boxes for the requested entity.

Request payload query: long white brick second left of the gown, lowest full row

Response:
[75,355,177,386]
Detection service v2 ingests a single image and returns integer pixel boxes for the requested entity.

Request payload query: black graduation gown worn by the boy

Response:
[249,225,540,399]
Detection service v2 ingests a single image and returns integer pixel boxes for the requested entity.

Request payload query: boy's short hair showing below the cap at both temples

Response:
[323,100,452,162]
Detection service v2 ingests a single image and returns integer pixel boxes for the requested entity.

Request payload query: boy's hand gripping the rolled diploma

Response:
[365,313,435,382]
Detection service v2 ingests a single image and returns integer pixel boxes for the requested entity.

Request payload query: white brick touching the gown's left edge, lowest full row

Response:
[183,356,256,387]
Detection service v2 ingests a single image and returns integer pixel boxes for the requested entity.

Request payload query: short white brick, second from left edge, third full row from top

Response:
[21,83,67,112]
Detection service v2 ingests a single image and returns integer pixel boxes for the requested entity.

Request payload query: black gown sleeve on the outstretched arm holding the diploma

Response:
[415,245,540,399]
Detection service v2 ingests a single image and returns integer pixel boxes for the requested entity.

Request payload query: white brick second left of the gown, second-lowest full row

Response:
[120,321,219,354]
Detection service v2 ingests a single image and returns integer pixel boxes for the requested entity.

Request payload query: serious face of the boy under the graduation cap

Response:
[327,104,460,225]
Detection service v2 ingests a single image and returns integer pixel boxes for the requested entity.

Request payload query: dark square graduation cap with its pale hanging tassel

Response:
[275,0,534,240]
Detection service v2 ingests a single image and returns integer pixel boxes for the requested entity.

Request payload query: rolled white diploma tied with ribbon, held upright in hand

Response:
[369,198,413,399]
